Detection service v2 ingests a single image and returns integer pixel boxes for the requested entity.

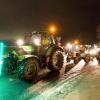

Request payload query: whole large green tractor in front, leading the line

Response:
[5,32,64,82]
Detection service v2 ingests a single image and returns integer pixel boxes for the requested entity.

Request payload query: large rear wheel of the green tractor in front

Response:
[48,49,64,71]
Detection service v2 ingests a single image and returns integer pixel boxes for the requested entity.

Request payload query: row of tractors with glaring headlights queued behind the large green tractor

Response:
[66,44,100,64]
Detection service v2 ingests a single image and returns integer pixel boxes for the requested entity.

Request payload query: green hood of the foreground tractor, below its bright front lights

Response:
[4,45,34,61]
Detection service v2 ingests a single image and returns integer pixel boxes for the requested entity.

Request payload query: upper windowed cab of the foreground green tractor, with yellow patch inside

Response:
[24,32,55,46]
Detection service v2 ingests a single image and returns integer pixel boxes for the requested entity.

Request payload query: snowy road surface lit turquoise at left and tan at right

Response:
[0,60,100,100]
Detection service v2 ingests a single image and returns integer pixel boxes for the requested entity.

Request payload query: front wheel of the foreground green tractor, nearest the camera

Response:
[17,58,39,82]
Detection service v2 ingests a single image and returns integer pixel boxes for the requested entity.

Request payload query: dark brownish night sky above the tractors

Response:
[0,0,100,41]
